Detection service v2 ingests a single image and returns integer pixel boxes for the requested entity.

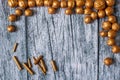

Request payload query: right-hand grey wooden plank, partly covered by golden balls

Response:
[99,0,120,80]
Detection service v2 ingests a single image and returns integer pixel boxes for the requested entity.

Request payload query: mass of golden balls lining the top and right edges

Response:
[7,0,120,65]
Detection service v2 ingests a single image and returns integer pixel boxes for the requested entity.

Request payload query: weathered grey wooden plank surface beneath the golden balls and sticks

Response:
[0,0,120,80]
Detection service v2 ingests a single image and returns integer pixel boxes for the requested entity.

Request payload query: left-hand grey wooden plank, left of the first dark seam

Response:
[0,0,27,80]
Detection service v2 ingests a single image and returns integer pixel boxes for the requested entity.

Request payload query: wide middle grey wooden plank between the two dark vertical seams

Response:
[27,8,98,80]
